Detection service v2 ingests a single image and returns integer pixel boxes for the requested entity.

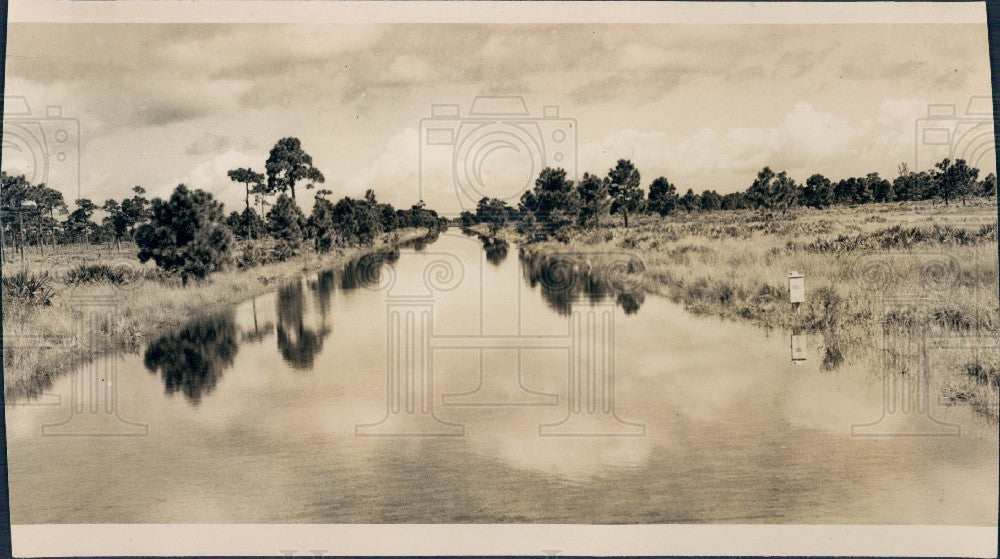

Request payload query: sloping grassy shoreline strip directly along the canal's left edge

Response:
[3,229,428,404]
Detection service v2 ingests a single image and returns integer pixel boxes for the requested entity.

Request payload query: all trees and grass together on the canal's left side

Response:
[0,138,447,394]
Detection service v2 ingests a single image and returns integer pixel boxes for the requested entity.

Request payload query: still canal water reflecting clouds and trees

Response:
[6,232,998,526]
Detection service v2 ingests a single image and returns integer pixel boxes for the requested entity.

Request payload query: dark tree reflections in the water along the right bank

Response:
[520,249,646,315]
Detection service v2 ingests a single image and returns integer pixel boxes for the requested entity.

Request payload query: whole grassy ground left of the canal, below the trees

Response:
[3,229,426,399]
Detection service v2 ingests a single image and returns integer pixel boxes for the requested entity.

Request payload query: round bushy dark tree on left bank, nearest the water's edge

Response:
[136,184,233,285]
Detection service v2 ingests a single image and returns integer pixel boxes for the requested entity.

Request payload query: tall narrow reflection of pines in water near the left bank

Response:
[278,281,332,370]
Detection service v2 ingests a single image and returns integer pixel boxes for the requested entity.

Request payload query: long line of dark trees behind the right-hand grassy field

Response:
[459,159,997,235]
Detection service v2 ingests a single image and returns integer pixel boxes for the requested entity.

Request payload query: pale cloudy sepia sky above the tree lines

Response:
[2,23,995,212]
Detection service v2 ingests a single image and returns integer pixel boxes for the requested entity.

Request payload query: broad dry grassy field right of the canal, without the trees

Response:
[520,199,1000,419]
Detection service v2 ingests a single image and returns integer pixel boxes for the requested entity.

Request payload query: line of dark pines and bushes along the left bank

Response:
[0,137,447,283]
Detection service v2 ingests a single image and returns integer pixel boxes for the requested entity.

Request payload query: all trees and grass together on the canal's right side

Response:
[461,160,1000,418]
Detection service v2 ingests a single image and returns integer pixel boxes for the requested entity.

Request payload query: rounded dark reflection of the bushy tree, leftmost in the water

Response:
[143,312,239,405]
